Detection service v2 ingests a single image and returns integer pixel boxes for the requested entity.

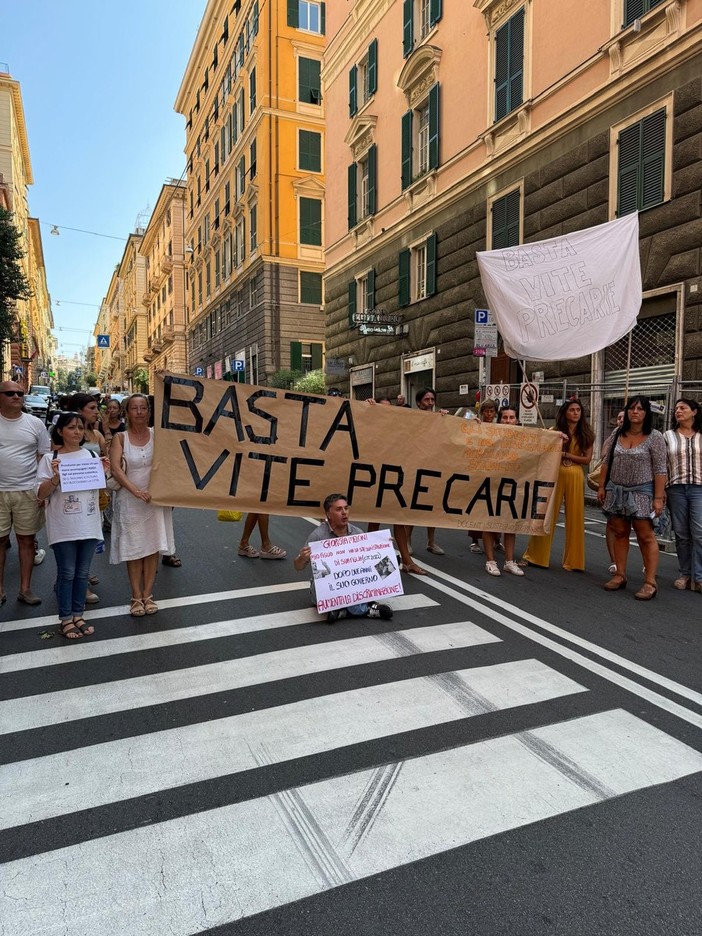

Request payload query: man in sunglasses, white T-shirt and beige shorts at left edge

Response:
[0,380,51,605]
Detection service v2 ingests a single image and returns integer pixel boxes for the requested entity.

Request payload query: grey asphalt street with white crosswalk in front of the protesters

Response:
[0,510,702,936]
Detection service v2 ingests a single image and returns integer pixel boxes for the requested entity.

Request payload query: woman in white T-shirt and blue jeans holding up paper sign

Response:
[37,413,106,640]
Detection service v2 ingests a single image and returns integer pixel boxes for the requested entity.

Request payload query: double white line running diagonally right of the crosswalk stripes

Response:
[412,563,702,728]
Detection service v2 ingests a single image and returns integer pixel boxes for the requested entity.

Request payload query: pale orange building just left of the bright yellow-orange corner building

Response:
[139,179,187,387]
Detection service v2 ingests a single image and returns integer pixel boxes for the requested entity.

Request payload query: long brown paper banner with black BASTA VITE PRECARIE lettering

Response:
[150,373,561,534]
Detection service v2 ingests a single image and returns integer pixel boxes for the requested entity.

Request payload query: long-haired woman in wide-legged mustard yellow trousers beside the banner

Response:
[524,400,595,572]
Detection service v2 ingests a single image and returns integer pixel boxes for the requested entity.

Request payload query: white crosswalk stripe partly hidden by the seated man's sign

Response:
[0,595,438,674]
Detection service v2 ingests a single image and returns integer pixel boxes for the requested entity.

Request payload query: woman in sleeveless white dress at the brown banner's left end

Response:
[110,393,175,617]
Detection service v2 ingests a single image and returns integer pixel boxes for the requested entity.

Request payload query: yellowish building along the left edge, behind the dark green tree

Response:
[0,63,53,387]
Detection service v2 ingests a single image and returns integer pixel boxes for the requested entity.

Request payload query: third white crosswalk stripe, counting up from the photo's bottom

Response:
[0,621,500,734]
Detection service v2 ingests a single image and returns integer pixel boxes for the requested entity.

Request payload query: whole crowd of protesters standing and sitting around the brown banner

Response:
[0,381,702,640]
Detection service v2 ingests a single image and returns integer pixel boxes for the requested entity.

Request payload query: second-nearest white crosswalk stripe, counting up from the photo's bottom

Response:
[0,660,587,828]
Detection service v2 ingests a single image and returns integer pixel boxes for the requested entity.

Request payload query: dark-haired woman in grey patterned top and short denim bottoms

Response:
[597,396,667,601]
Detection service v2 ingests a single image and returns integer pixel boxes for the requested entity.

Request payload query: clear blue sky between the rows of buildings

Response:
[0,0,206,354]
